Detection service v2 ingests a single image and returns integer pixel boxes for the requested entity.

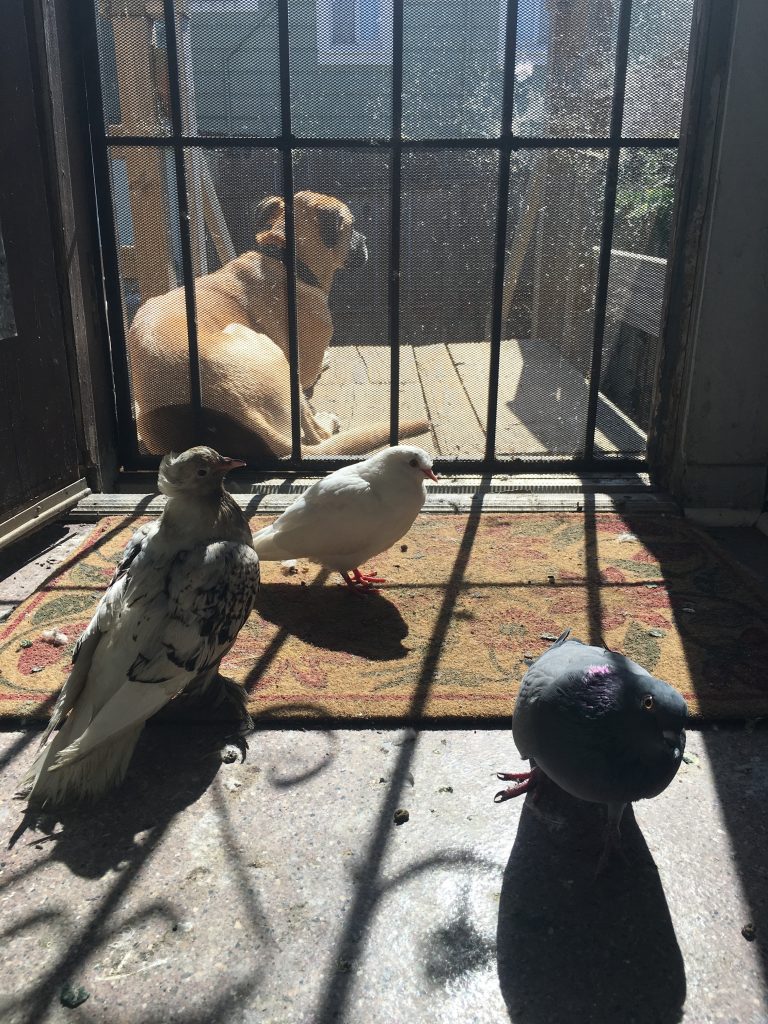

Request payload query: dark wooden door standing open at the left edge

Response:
[0,0,85,544]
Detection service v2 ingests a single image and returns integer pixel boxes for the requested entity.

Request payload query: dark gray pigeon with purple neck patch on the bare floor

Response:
[496,630,688,869]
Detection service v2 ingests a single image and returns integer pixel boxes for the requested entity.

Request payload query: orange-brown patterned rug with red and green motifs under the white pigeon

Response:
[0,513,768,725]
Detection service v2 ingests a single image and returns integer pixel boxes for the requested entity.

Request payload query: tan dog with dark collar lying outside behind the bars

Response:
[127,191,429,458]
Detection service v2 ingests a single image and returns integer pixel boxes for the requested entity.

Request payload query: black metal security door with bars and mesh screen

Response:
[86,0,691,472]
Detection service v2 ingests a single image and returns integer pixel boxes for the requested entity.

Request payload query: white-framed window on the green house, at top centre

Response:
[317,0,392,63]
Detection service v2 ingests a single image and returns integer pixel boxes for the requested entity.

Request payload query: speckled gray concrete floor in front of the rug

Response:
[0,527,768,1024]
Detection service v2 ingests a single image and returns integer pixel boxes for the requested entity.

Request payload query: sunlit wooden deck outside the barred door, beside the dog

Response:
[312,339,646,459]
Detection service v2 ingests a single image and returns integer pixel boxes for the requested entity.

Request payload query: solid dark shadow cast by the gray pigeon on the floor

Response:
[497,785,686,1024]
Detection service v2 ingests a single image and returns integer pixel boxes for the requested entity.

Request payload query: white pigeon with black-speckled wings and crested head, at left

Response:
[19,447,259,805]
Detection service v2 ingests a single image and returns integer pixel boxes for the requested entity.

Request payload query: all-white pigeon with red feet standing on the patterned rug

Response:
[253,444,437,590]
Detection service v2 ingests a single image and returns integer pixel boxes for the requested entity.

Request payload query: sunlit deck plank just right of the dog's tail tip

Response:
[414,345,485,459]
